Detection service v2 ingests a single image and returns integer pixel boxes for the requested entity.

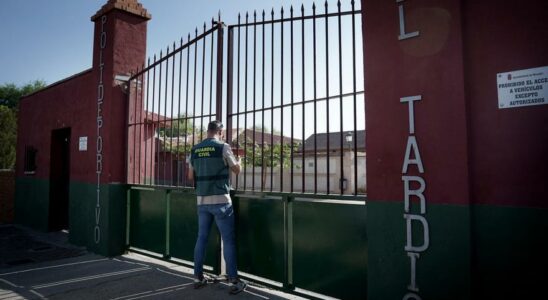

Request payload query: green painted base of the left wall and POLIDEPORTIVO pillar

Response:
[15,177,127,256]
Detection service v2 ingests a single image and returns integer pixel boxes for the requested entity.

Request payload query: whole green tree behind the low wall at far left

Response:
[0,80,46,169]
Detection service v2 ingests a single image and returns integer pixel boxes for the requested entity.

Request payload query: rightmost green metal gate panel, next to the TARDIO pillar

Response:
[290,199,367,299]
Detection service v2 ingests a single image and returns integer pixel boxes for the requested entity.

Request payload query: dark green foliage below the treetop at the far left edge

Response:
[0,105,17,169]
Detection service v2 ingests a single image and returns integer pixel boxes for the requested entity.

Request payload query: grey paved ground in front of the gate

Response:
[0,225,302,300]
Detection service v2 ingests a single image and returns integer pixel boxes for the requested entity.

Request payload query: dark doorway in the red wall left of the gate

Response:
[49,128,70,231]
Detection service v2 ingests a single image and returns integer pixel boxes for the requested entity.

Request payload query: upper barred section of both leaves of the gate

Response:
[127,1,367,195]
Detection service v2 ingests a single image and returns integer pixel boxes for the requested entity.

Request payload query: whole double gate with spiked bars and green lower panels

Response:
[127,1,367,299]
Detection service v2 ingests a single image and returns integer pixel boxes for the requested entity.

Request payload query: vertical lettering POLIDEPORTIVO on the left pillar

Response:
[93,16,107,244]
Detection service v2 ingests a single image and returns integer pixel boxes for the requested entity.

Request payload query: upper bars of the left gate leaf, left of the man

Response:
[127,18,223,187]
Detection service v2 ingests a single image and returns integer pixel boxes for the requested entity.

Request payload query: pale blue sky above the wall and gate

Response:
[0,0,364,136]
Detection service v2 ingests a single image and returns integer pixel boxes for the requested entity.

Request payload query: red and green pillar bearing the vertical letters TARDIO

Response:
[362,0,471,299]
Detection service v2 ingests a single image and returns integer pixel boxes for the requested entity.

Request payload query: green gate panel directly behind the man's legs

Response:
[169,191,221,274]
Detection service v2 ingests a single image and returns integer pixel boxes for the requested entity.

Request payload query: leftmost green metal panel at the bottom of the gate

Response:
[129,189,167,255]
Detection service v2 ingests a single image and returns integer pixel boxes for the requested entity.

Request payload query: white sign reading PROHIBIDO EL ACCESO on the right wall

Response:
[497,66,548,109]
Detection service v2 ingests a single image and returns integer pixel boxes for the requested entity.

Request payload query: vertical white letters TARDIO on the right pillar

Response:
[397,94,430,300]
